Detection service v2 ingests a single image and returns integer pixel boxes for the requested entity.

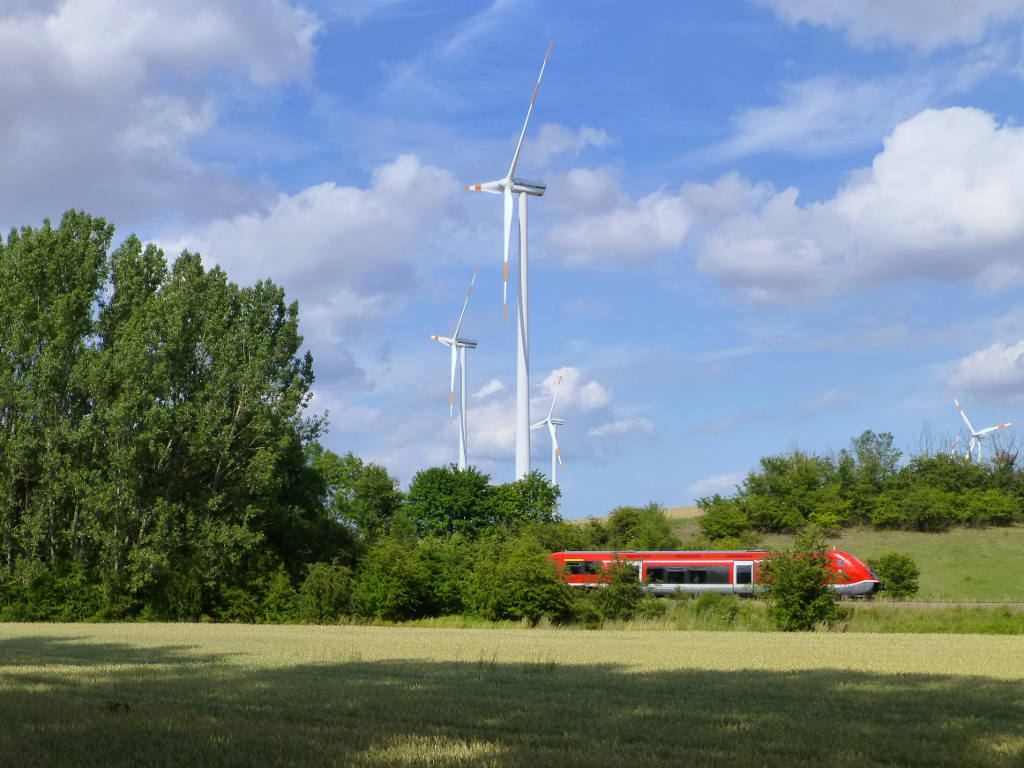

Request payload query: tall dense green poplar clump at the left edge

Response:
[0,211,342,617]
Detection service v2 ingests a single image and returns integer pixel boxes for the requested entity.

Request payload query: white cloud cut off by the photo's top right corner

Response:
[755,0,1024,52]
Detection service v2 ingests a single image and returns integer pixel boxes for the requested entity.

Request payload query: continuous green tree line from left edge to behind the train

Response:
[0,211,688,622]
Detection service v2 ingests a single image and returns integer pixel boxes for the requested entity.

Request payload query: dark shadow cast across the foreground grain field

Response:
[0,634,1024,768]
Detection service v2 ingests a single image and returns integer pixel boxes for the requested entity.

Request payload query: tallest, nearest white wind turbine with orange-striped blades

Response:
[466,43,551,479]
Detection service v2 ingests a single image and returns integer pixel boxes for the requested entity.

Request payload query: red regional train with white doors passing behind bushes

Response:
[549,550,883,597]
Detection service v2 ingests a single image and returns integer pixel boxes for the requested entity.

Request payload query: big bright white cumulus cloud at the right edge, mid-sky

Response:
[697,108,1024,302]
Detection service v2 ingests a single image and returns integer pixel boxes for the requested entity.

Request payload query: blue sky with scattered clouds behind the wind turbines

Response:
[6,0,1024,518]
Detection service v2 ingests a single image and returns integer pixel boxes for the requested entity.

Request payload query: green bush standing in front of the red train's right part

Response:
[758,529,844,632]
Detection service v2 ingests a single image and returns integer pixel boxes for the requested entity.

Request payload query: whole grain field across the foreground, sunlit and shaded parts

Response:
[0,625,1024,768]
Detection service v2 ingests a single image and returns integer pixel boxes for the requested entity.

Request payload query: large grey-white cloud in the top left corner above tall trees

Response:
[0,0,319,228]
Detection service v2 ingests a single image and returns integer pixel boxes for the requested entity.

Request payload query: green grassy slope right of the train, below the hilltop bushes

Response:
[764,525,1024,601]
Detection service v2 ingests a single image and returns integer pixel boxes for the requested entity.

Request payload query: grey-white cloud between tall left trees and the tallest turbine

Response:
[160,155,459,385]
